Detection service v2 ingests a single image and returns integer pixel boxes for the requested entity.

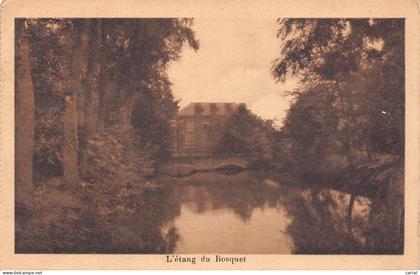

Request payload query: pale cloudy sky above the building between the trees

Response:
[169,18,297,125]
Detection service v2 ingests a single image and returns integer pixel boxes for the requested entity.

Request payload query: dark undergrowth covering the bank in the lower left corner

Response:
[16,178,179,253]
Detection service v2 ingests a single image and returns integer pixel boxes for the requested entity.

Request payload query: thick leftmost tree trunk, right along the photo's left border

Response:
[15,20,35,202]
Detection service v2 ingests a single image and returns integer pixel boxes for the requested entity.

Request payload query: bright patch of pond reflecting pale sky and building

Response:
[164,185,292,254]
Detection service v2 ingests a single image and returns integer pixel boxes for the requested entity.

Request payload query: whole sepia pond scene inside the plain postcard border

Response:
[15,18,405,254]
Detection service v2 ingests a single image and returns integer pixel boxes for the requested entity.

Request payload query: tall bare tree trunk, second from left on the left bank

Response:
[63,21,89,184]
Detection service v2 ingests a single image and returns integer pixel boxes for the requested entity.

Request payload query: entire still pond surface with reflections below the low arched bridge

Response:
[135,172,400,254]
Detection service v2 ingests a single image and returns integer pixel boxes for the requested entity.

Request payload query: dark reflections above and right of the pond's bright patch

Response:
[171,173,401,254]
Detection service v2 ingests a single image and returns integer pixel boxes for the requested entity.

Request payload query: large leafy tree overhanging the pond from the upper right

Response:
[273,19,404,170]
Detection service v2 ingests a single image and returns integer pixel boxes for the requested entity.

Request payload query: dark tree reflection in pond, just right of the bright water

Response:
[284,190,361,254]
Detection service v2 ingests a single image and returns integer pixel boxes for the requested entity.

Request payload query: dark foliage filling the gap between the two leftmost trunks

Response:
[26,18,73,180]
